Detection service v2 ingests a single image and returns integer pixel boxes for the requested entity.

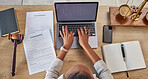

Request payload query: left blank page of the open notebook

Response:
[102,43,127,73]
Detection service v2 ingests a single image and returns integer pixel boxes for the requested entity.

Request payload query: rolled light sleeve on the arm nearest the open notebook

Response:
[94,60,114,79]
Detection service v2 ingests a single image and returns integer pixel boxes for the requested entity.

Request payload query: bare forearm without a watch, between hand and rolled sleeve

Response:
[83,44,101,64]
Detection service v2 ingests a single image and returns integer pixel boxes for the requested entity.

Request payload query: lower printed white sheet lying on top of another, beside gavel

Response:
[23,30,56,75]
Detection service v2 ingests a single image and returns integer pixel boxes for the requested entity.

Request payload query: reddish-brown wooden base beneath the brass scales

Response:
[109,7,148,27]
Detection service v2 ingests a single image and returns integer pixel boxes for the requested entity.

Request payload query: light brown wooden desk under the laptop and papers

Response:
[0,5,148,79]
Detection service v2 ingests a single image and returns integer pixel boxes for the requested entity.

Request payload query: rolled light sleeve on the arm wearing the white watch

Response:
[45,58,63,79]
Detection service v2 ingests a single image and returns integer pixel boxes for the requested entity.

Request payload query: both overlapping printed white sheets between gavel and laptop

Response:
[23,11,56,75]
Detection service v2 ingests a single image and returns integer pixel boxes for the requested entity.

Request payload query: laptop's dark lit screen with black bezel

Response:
[55,2,98,22]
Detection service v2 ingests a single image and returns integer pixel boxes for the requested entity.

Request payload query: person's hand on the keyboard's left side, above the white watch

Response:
[60,26,74,50]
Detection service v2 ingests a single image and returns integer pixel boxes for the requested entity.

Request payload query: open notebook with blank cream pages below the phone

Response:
[102,41,146,73]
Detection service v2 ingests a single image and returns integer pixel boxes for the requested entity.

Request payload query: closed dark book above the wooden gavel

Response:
[0,8,19,36]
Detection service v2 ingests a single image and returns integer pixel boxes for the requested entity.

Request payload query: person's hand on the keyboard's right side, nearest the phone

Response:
[78,27,90,48]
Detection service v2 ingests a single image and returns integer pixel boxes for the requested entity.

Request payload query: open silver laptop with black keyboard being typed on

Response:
[54,2,98,49]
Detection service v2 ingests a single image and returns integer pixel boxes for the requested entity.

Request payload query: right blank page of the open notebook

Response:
[122,41,146,70]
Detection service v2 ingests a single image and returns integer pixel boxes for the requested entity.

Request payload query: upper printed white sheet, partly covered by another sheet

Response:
[25,11,54,45]
